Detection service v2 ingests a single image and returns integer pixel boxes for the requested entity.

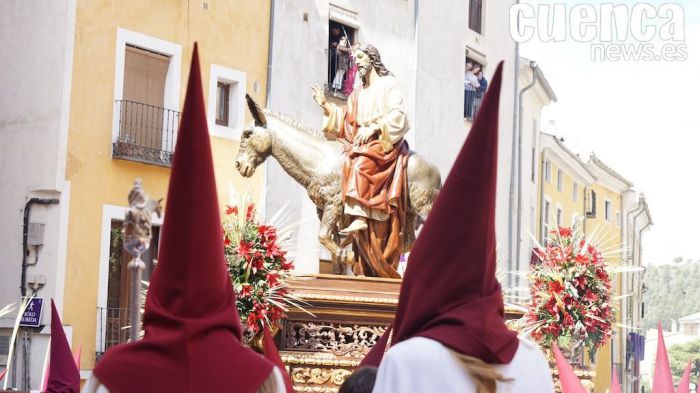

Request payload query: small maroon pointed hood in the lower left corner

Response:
[46,299,80,393]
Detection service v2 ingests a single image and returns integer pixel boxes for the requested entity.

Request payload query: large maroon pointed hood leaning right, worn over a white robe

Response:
[360,63,519,366]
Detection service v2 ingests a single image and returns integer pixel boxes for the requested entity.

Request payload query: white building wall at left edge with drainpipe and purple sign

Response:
[0,0,76,388]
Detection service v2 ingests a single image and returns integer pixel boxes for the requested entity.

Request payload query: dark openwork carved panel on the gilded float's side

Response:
[283,321,386,358]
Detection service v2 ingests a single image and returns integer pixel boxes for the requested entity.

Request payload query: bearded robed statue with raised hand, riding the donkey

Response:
[312,45,409,277]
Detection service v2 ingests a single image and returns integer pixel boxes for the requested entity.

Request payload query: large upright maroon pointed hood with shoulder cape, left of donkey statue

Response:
[94,44,273,393]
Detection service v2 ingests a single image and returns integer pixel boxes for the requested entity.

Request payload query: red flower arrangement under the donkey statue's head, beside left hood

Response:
[222,203,297,339]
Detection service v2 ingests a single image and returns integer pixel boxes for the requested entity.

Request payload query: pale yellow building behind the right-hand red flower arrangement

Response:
[534,133,633,393]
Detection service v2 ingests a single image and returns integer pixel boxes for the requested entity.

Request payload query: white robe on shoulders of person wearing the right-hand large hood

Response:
[372,337,554,393]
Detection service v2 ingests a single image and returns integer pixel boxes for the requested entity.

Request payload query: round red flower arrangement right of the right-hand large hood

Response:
[525,225,615,356]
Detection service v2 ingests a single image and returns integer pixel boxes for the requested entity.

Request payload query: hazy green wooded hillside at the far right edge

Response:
[643,261,700,330]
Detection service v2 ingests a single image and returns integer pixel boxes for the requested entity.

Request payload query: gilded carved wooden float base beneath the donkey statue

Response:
[278,274,523,393]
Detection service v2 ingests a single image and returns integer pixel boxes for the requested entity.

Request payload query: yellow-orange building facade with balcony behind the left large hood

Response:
[63,0,270,377]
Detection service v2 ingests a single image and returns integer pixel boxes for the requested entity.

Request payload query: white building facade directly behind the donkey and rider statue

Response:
[264,0,519,273]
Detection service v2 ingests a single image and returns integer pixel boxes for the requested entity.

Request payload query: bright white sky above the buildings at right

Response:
[521,0,700,264]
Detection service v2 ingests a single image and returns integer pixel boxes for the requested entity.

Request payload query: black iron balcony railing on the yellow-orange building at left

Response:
[112,100,180,166]
